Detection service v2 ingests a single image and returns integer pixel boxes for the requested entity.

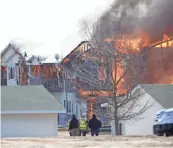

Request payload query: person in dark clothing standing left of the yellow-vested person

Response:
[69,115,79,136]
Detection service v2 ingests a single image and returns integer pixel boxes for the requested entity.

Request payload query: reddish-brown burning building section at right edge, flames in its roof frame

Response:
[144,39,173,84]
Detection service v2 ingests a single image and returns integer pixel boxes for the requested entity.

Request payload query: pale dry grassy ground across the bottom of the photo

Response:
[1,132,173,148]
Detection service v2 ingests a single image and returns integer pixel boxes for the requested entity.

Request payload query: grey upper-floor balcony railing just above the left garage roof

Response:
[30,79,74,92]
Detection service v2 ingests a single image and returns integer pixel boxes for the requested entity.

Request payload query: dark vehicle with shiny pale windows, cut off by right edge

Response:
[153,108,173,136]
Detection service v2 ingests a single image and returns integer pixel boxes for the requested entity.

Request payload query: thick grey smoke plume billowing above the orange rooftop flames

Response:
[94,0,173,42]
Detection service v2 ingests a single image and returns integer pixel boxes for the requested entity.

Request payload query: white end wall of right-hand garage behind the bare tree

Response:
[124,93,163,135]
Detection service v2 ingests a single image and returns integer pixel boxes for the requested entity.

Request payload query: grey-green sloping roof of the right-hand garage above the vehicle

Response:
[140,84,173,108]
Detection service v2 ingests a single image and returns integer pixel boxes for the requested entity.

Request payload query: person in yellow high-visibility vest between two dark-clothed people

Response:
[79,115,88,136]
